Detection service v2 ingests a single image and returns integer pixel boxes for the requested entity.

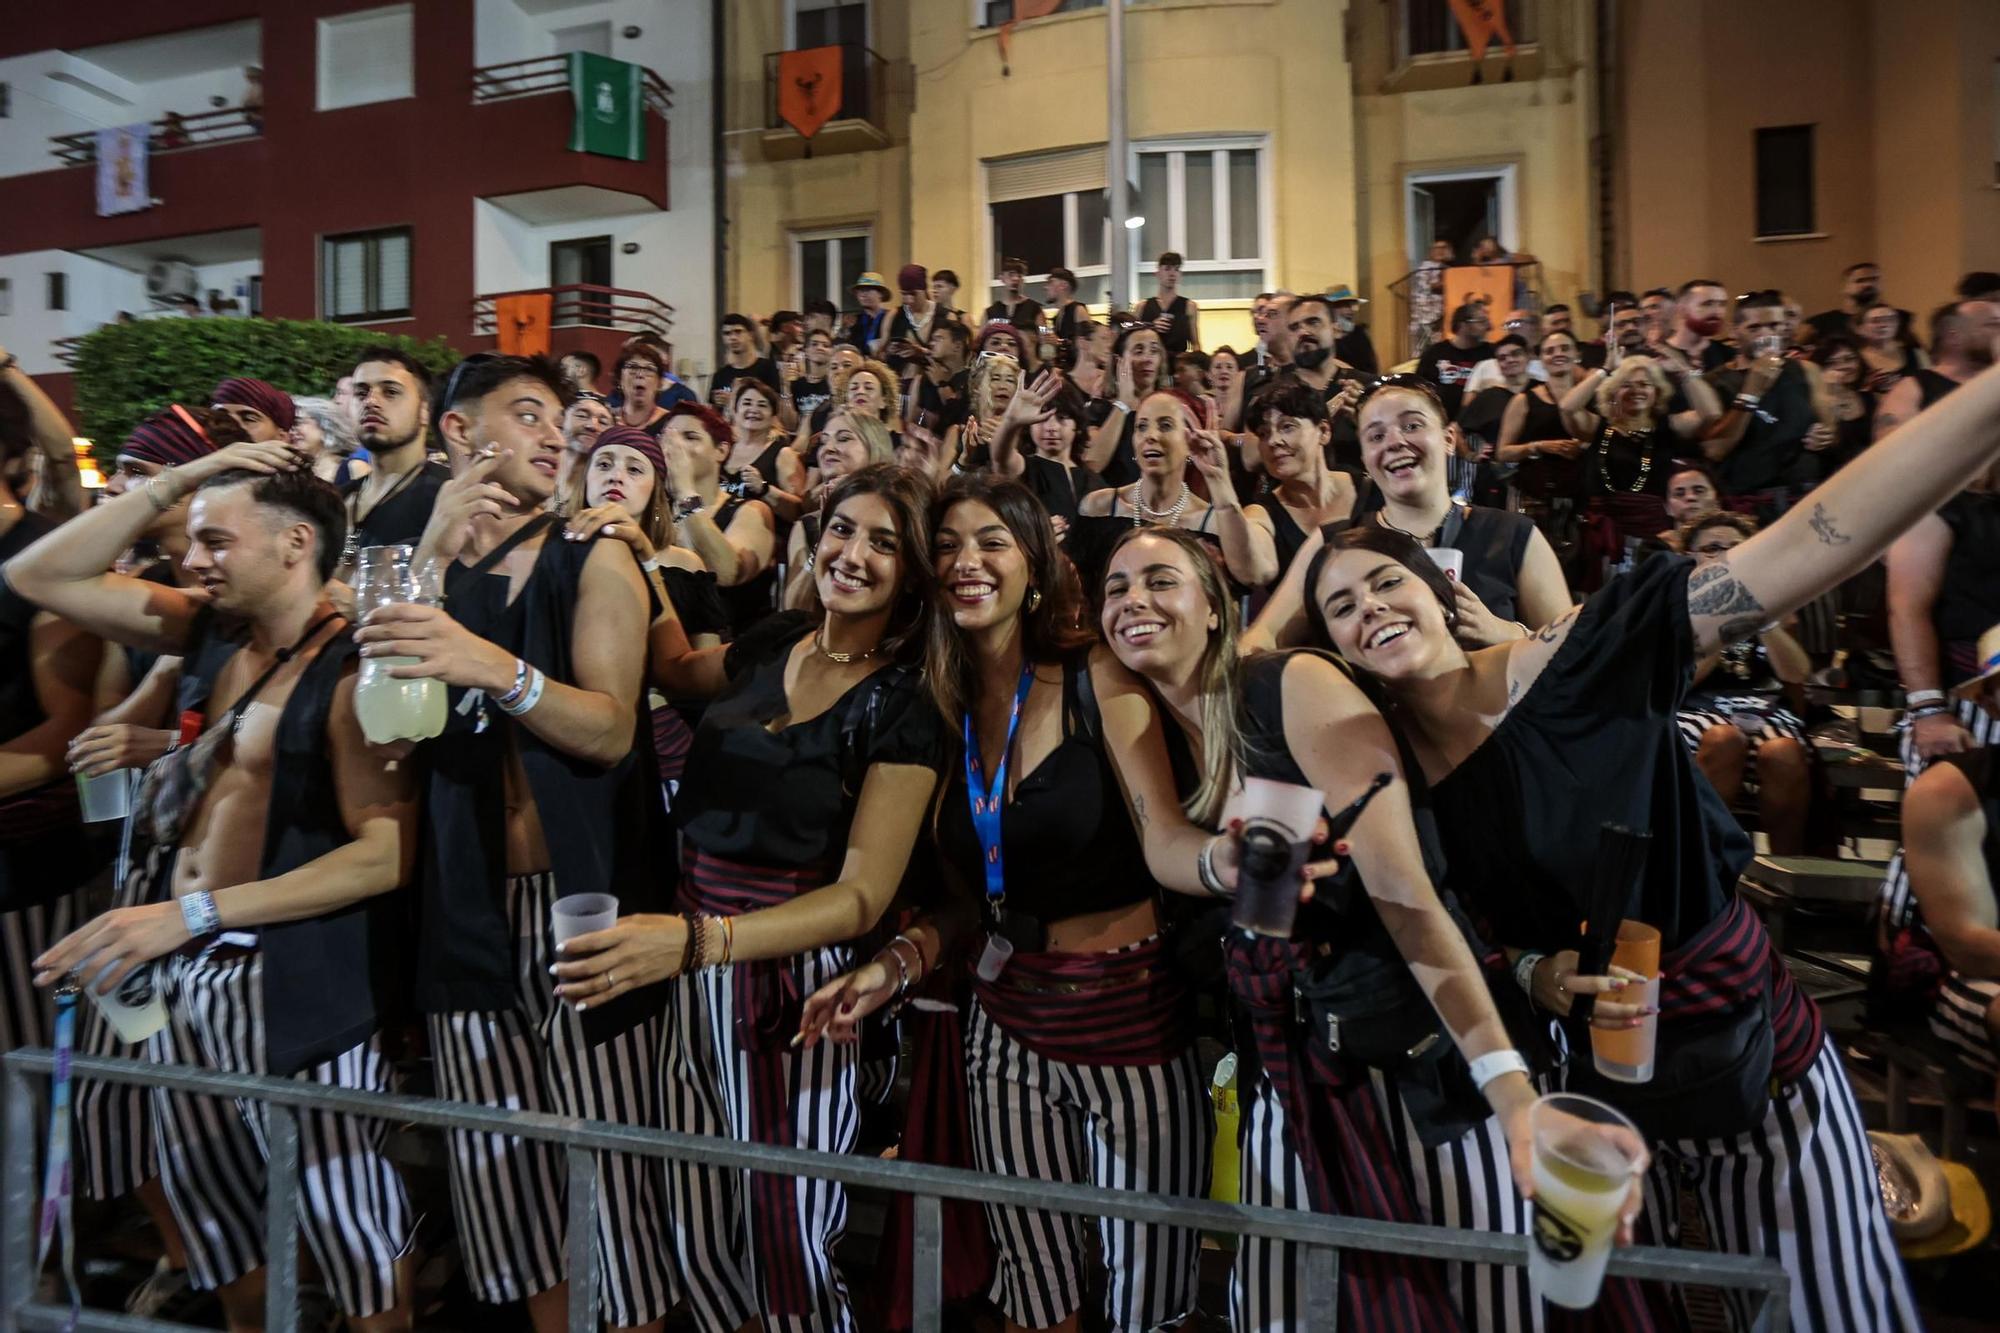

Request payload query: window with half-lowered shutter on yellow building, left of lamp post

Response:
[986,146,1110,302]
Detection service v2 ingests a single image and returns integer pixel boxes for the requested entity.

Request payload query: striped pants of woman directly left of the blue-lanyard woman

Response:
[660,949,860,1333]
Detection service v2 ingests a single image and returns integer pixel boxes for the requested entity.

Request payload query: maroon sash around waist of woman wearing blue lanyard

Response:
[972,935,1194,1065]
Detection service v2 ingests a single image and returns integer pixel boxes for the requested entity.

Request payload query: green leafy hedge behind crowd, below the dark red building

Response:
[76,318,458,462]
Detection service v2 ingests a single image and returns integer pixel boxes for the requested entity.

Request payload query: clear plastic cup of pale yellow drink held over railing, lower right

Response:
[1528,1093,1646,1309]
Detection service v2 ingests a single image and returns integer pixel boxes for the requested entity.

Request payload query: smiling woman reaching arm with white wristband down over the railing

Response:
[1102,528,1630,1331]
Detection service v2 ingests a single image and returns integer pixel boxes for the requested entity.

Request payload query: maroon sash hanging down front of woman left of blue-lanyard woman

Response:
[680,845,826,1315]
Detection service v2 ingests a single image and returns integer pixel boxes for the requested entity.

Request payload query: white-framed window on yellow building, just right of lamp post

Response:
[1132,140,1270,300]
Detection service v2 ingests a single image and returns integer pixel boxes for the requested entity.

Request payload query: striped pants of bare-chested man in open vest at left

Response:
[148,949,412,1317]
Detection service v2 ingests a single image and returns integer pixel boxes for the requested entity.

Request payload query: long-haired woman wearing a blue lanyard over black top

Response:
[802,474,1218,1331]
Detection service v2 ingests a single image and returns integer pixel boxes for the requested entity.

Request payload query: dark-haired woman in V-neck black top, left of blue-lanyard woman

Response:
[556,466,944,1329]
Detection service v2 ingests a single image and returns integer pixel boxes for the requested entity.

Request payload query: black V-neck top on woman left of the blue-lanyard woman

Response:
[674,610,946,875]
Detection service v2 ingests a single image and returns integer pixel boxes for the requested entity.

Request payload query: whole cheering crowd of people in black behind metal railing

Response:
[0,239,2000,1333]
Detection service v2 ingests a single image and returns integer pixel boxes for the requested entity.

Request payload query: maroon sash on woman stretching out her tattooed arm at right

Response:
[1660,899,1826,1083]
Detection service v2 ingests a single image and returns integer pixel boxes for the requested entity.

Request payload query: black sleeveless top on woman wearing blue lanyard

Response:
[938,652,1158,925]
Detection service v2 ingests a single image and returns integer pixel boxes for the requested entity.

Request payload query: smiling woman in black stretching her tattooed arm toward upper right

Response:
[1280,370,2000,1329]
